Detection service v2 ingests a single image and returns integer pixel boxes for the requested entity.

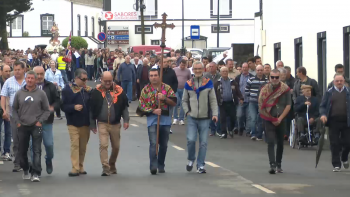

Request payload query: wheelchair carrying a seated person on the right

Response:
[289,117,320,150]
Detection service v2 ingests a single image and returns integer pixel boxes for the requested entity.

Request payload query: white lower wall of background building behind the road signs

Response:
[107,20,254,49]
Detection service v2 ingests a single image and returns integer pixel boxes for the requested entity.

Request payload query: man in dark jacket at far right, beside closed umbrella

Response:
[320,74,350,172]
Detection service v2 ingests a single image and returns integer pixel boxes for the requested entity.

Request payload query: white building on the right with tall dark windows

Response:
[254,0,350,94]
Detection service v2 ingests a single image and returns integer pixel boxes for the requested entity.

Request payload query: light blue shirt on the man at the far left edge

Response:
[1,76,26,115]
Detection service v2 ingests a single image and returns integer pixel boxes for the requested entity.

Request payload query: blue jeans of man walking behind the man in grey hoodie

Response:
[30,124,53,161]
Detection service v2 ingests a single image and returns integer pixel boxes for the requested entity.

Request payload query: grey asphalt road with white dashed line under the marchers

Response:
[0,81,350,197]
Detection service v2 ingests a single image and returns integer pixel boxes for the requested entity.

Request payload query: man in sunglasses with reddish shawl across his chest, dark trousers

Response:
[258,69,292,174]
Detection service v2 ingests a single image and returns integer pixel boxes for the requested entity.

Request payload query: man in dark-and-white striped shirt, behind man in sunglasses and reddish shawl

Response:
[245,65,269,140]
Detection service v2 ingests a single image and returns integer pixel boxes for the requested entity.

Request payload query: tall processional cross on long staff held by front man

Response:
[153,12,175,155]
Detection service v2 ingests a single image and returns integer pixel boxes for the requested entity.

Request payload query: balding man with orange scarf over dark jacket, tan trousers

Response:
[90,71,130,176]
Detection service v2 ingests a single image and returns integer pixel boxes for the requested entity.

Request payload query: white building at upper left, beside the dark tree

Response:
[7,0,102,50]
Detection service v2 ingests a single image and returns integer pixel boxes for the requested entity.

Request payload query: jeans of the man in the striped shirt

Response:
[248,102,263,139]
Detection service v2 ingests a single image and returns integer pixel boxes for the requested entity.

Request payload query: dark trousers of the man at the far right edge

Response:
[329,119,350,167]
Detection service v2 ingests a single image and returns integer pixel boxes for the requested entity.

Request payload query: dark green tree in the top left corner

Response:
[0,0,32,49]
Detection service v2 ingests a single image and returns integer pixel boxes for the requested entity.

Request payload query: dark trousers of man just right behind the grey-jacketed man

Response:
[220,101,236,135]
